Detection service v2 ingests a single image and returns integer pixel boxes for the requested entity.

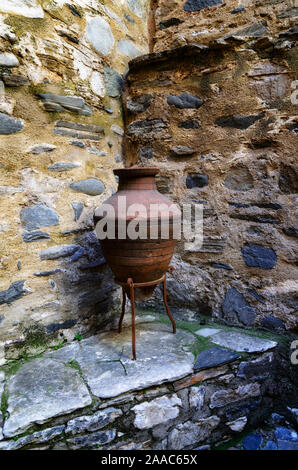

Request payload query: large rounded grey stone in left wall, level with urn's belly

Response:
[20,203,59,230]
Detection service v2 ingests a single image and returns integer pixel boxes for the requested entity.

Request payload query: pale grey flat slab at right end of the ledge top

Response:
[210,331,277,353]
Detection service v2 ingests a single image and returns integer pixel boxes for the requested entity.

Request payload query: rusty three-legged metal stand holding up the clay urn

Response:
[115,266,176,360]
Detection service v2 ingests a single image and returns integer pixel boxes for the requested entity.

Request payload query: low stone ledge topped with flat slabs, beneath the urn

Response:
[0,317,297,450]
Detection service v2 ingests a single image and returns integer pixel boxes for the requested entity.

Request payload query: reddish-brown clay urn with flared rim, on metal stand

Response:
[94,167,181,300]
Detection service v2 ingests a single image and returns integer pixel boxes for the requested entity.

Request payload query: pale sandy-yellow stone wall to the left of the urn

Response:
[0,0,148,363]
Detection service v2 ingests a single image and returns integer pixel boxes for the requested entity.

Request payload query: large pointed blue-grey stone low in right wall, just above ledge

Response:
[222,287,256,326]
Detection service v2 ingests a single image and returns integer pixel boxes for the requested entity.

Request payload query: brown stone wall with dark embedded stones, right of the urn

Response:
[124,0,298,329]
